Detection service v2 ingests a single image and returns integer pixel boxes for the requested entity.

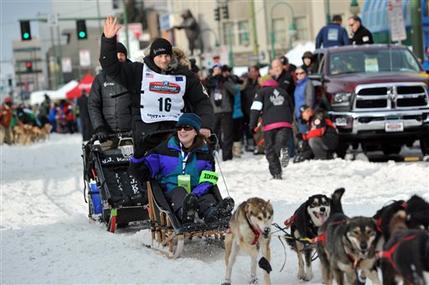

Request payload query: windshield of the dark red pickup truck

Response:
[329,49,421,75]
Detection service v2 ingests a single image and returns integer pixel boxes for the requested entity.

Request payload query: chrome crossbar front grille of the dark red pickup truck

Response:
[354,83,428,110]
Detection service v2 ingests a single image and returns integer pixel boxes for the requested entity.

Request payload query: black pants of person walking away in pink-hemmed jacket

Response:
[264,128,292,176]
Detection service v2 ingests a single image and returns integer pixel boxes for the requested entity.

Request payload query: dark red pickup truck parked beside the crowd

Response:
[309,44,429,157]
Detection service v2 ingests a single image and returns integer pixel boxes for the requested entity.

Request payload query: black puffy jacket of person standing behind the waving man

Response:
[88,71,131,132]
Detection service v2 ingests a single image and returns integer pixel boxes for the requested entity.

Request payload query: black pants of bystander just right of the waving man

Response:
[214,113,234,160]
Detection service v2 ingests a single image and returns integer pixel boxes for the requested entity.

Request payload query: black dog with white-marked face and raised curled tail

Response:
[285,188,345,281]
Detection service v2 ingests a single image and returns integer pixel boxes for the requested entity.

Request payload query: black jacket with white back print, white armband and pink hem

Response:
[249,84,293,129]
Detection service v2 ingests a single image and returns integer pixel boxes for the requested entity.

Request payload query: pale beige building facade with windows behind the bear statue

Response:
[168,0,364,66]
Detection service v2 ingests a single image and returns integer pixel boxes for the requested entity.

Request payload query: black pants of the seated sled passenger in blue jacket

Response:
[165,187,218,219]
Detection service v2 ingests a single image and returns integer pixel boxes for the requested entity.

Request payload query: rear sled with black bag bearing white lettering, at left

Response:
[82,133,149,233]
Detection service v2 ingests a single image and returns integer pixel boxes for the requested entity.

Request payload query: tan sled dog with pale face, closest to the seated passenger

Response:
[223,198,273,284]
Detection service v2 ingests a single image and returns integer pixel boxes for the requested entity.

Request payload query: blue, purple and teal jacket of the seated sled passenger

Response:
[132,135,214,197]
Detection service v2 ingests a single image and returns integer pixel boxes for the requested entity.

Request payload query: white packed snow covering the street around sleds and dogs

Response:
[0,134,429,284]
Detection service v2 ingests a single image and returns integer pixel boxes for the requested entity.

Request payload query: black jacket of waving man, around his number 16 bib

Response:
[100,35,214,129]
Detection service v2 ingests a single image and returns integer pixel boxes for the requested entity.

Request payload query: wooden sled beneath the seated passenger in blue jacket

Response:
[146,181,230,258]
